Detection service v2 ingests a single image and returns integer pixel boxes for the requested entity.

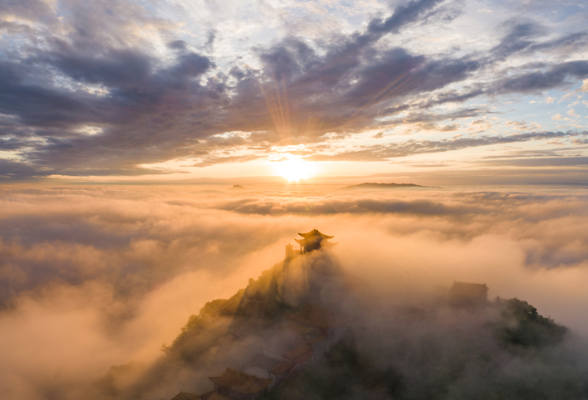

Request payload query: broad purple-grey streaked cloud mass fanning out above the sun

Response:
[0,0,588,179]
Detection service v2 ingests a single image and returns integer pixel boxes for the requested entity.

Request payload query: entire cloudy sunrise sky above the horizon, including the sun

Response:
[0,0,588,184]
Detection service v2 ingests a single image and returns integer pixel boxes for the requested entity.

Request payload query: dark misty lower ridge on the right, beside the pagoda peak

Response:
[268,299,576,400]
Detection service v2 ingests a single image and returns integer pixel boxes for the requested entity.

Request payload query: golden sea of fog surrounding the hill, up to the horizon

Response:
[0,185,588,399]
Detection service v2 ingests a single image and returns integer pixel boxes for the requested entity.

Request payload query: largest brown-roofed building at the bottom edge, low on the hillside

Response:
[208,368,272,400]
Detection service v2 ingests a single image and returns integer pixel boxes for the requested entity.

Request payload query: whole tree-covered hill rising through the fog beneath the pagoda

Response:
[101,250,588,400]
